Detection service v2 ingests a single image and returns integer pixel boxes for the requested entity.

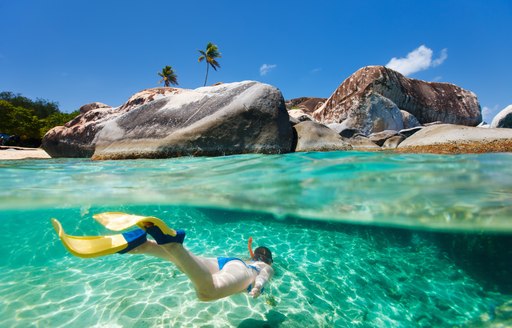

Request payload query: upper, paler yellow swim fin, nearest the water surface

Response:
[93,212,176,237]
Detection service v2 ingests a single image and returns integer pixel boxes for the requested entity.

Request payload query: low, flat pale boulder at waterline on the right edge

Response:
[397,124,512,154]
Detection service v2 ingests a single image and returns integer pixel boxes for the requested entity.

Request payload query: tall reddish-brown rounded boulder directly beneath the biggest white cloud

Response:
[313,66,482,133]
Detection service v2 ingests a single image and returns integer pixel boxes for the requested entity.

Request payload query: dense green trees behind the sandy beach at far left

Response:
[0,91,79,147]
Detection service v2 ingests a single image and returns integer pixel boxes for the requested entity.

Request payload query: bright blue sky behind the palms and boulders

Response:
[0,0,512,120]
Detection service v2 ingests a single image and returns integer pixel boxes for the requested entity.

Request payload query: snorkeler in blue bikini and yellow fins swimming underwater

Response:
[52,212,274,301]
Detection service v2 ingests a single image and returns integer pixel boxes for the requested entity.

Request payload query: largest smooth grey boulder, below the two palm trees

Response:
[43,81,293,159]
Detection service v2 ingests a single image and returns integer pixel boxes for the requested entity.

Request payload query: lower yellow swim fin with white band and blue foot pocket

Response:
[52,219,146,258]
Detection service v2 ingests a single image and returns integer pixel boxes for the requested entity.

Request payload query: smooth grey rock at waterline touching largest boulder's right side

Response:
[293,121,352,152]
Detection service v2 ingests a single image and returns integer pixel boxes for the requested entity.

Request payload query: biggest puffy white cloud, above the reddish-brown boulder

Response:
[386,45,448,76]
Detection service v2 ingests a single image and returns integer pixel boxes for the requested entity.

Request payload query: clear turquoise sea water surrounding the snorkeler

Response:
[0,152,512,327]
